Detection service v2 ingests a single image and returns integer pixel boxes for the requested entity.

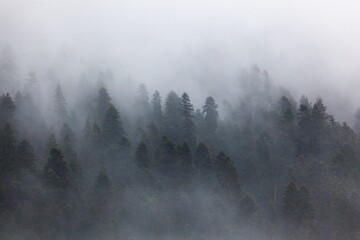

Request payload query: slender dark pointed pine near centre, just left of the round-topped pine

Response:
[181,93,196,147]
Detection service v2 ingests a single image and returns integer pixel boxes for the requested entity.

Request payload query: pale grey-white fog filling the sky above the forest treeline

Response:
[0,0,360,121]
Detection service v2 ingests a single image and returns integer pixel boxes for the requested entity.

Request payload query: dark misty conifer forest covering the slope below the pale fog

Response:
[0,47,360,240]
